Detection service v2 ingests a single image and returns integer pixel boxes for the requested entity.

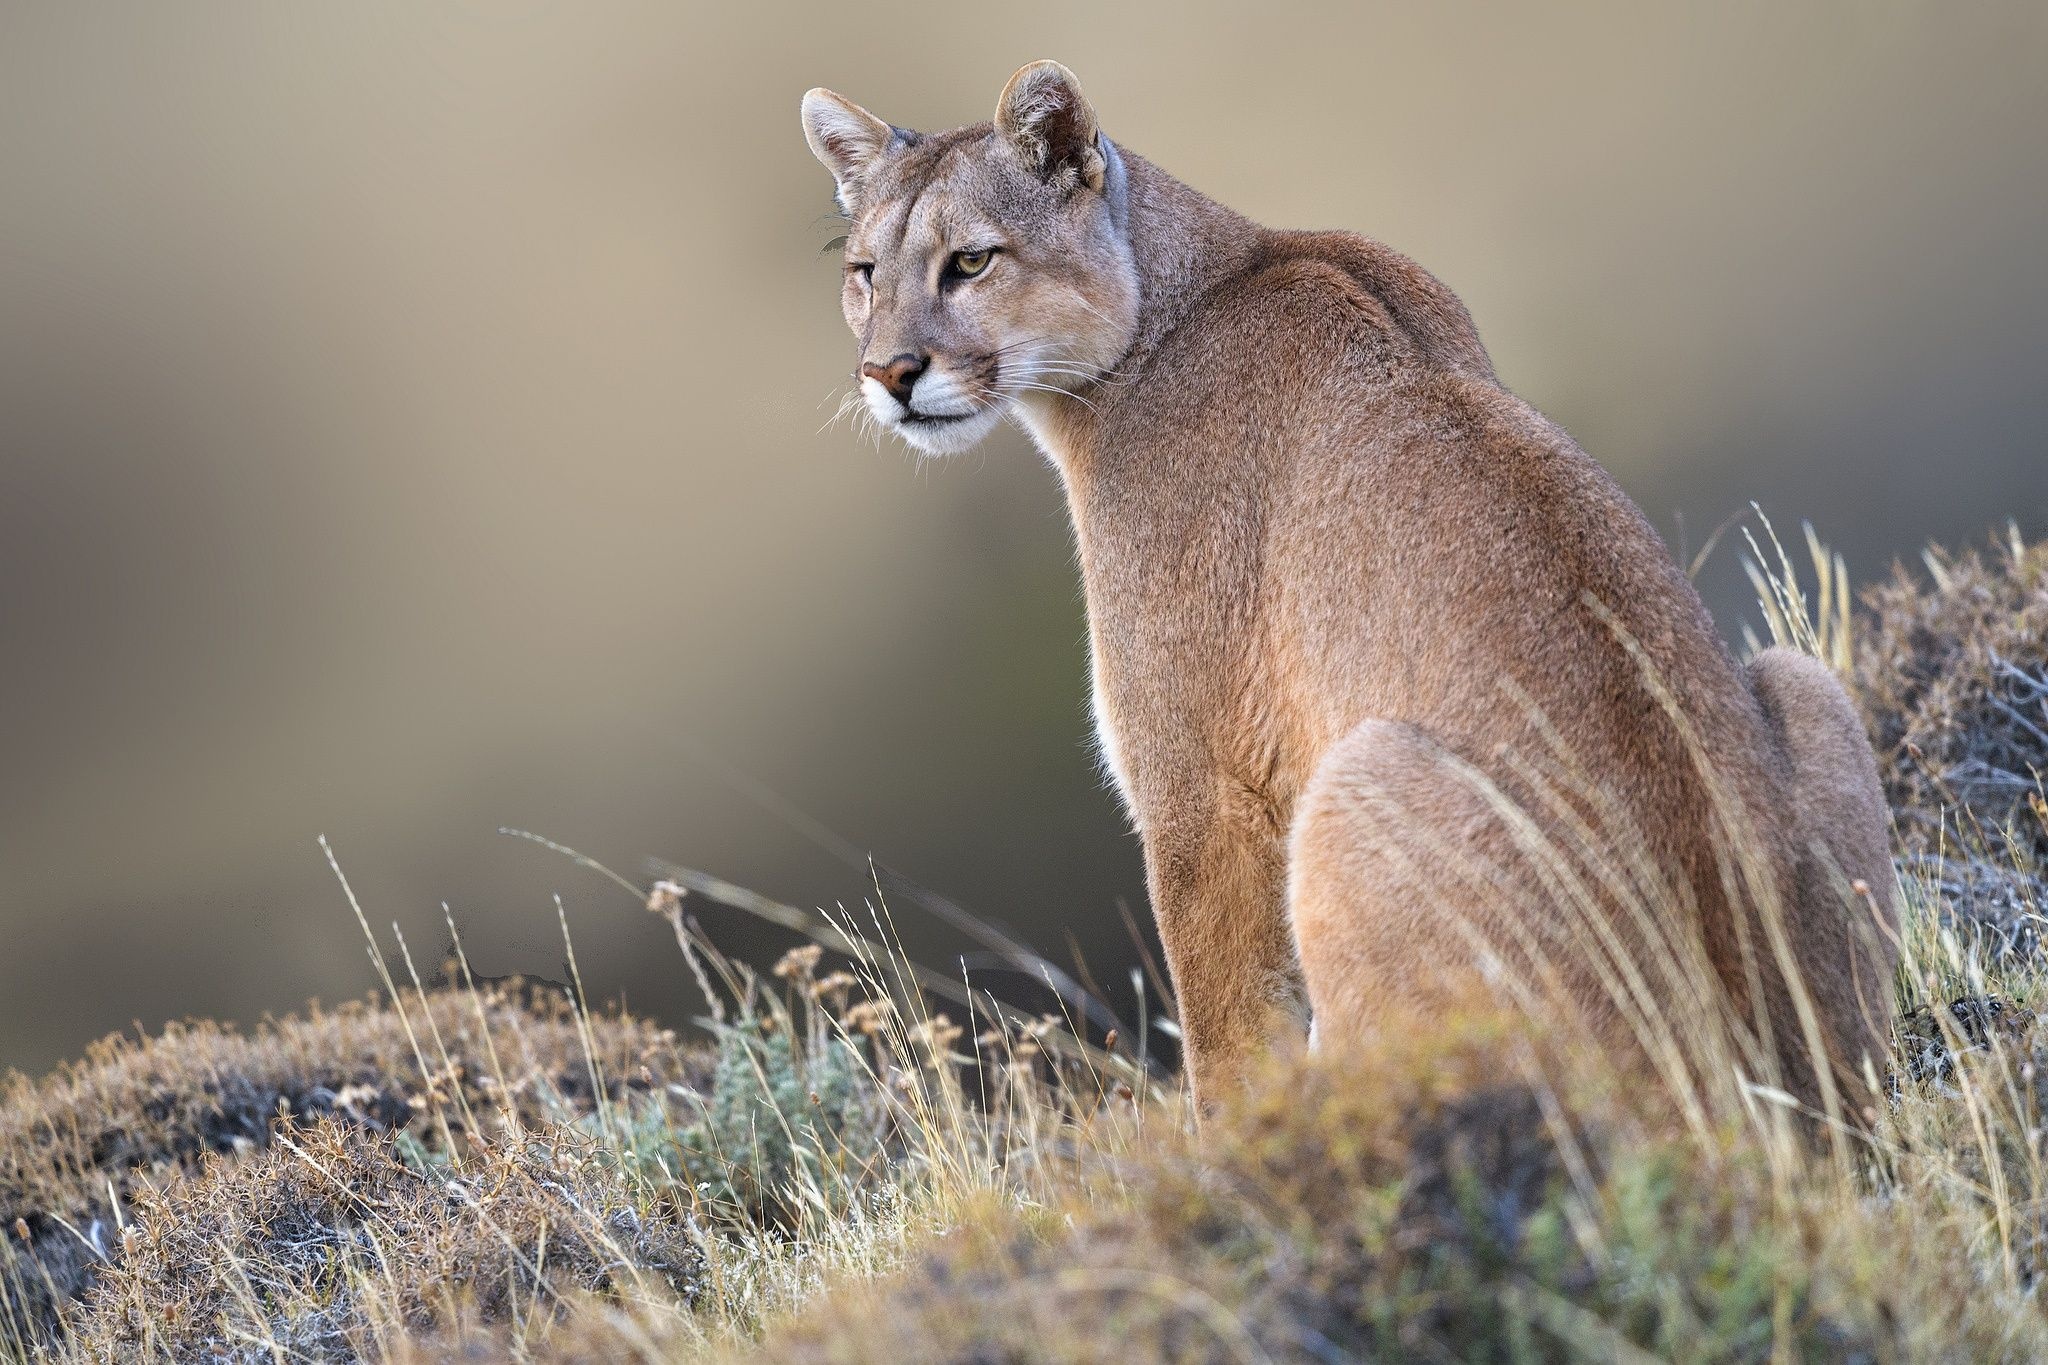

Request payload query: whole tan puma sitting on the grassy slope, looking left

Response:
[805,63,1896,1103]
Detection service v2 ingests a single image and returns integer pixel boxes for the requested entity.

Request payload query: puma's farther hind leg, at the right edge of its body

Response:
[1749,649,1898,1107]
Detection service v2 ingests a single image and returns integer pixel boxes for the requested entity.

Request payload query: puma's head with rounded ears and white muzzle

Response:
[803,61,1139,454]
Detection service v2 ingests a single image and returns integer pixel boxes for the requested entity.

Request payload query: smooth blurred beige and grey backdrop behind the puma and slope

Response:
[0,0,2048,1068]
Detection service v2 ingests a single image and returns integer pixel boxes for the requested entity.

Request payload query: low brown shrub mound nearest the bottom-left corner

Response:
[76,1119,702,1365]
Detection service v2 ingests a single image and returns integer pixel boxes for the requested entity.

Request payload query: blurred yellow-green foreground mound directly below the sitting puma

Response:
[766,1019,2048,1363]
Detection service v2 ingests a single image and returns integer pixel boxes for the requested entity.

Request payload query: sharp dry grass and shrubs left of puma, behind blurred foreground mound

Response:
[0,875,1163,1361]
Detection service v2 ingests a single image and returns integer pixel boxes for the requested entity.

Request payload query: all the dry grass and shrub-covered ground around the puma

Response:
[0,517,2048,1363]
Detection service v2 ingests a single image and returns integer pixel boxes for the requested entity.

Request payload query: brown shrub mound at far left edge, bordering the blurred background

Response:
[0,988,702,1340]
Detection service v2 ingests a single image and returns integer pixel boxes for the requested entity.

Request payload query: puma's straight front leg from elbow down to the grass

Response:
[1145,788,1303,1115]
